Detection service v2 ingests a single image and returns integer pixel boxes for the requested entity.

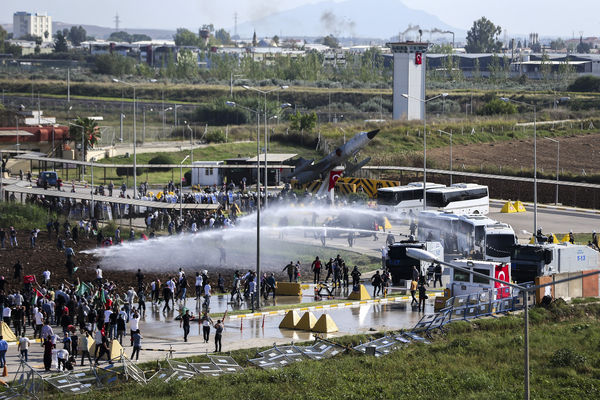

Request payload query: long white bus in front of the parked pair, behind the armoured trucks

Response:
[417,211,516,262]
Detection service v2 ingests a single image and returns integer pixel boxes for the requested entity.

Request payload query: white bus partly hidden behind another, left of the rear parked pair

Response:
[377,182,446,217]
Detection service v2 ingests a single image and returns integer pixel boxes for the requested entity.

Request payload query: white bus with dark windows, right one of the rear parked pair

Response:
[427,183,490,215]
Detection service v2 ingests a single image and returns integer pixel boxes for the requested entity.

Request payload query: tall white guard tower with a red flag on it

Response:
[387,42,429,120]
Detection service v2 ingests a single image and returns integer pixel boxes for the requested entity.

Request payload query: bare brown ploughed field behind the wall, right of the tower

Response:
[427,134,600,175]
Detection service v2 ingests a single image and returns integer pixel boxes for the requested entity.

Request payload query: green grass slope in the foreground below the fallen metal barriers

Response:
[62,300,600,399]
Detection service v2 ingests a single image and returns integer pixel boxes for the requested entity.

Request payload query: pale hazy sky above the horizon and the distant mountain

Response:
[0,0,600,37]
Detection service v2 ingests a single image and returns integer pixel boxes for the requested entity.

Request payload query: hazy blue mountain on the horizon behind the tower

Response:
[231,0,466,39]
